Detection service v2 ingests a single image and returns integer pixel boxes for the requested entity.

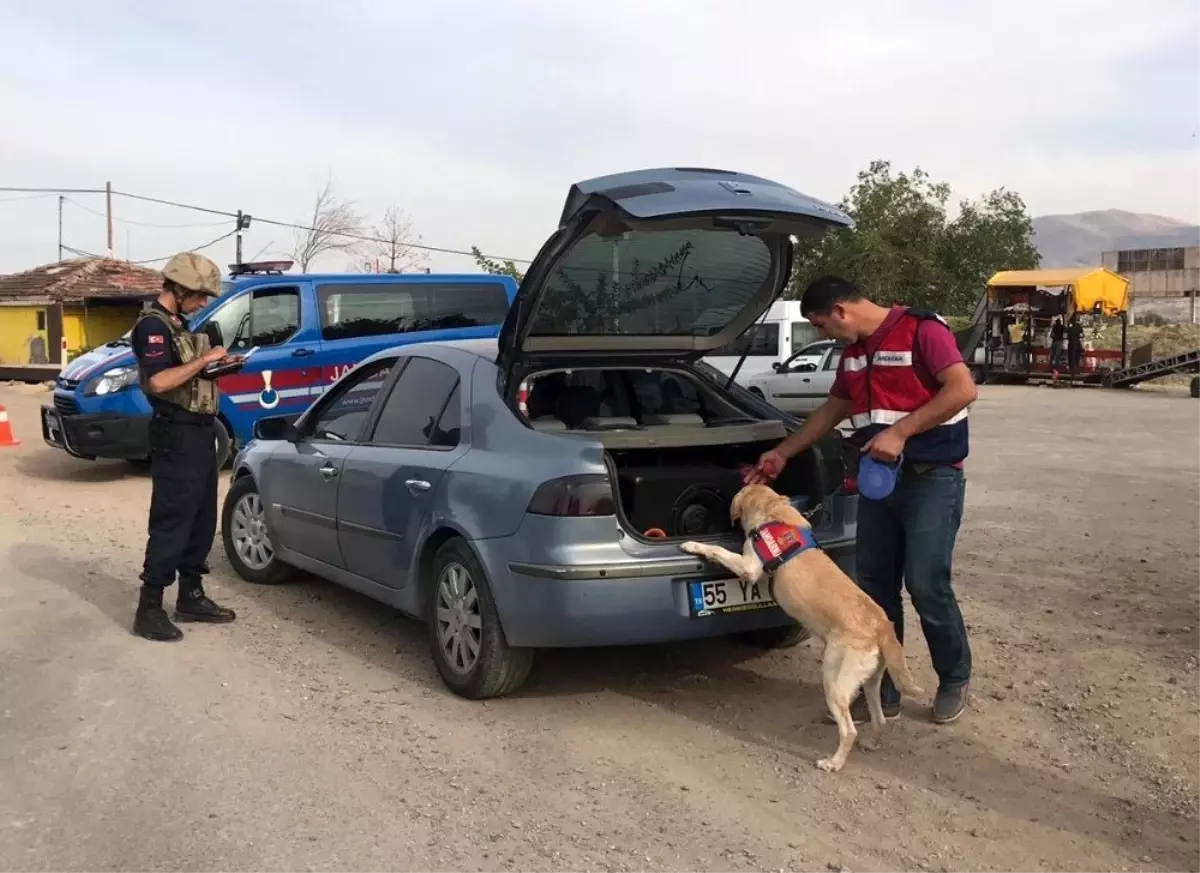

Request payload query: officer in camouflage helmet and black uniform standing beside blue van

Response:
[132,252,235,640]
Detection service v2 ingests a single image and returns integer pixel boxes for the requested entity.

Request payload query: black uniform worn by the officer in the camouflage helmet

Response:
[131,302,234,639]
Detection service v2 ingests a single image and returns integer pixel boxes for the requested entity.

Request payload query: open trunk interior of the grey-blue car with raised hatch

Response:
[526,368,822,538]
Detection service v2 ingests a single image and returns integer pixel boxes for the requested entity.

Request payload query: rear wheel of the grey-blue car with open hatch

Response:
[425,540,533,700]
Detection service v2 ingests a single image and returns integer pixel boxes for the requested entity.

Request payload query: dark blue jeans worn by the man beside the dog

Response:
[858,463,971,704]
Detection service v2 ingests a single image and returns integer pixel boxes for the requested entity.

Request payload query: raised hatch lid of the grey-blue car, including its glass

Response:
[499,168,853,374]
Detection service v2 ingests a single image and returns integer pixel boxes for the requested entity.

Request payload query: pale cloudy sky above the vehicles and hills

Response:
[0,0,1200,272]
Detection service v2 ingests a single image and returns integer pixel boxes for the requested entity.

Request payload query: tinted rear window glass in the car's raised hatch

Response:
[529,229,772,336]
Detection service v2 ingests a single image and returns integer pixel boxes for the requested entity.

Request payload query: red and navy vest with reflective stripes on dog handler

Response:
[841,309,970,464]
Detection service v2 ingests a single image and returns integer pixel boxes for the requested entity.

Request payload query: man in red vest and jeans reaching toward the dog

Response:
[748,276,977,724]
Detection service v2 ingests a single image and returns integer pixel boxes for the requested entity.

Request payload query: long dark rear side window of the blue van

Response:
[317,282,509,339]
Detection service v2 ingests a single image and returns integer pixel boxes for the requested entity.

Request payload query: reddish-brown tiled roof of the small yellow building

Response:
[0,258,162,302]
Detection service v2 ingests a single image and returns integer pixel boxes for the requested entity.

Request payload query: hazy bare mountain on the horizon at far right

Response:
[1033,209,1200,267]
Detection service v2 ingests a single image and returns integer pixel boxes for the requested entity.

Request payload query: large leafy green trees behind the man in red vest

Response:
[788,161,1038,315]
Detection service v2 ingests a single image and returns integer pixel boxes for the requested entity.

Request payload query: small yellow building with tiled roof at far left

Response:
[0,258,162,379]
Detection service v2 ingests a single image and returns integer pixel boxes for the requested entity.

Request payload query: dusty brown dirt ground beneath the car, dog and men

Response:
[0,386,1200,873]
